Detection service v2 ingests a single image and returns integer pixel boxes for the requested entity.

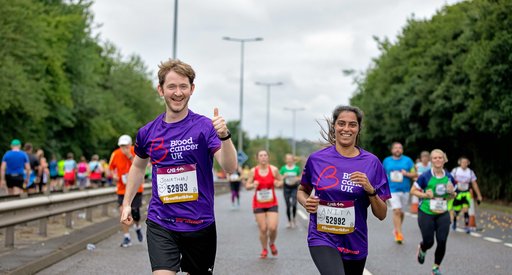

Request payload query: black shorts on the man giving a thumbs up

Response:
[146,220,217,275]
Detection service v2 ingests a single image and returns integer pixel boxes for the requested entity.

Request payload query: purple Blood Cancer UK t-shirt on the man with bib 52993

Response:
[135,110,221,232]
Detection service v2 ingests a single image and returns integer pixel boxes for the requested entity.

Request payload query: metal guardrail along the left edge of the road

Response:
[0,183,151,247]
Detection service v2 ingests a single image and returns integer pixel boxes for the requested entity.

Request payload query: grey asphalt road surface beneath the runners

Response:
[38,191,512,275]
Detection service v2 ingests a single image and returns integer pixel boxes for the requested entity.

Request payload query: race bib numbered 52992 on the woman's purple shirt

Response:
[316,201,356,234]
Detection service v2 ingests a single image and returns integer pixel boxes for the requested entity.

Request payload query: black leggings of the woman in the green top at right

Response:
[418,210,450,265]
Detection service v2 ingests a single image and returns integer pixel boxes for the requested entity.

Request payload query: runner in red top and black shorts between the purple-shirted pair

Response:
[246,150,282,259]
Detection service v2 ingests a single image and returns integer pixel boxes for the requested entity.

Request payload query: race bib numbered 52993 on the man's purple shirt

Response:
[156,164,199,203]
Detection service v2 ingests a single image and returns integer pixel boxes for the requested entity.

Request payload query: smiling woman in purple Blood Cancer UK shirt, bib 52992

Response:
[297,106,391,275]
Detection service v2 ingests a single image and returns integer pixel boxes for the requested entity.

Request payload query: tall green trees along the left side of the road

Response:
[0,0,160,160]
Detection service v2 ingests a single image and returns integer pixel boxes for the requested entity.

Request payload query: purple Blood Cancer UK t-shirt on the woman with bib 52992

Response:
[301,146,391,260]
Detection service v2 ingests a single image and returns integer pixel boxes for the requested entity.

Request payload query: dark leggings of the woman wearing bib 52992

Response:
[309,246,366,275]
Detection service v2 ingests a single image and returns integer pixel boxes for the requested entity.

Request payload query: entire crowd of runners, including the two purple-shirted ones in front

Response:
[1,60,482,274]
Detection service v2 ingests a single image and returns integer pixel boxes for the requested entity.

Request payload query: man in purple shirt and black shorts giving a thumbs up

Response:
[121,60,237,274]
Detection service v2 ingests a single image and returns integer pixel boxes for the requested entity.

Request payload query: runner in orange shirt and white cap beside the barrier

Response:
[109,135,144,247]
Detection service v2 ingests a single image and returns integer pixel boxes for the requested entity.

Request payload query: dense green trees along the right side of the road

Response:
[350,0,512,200]
